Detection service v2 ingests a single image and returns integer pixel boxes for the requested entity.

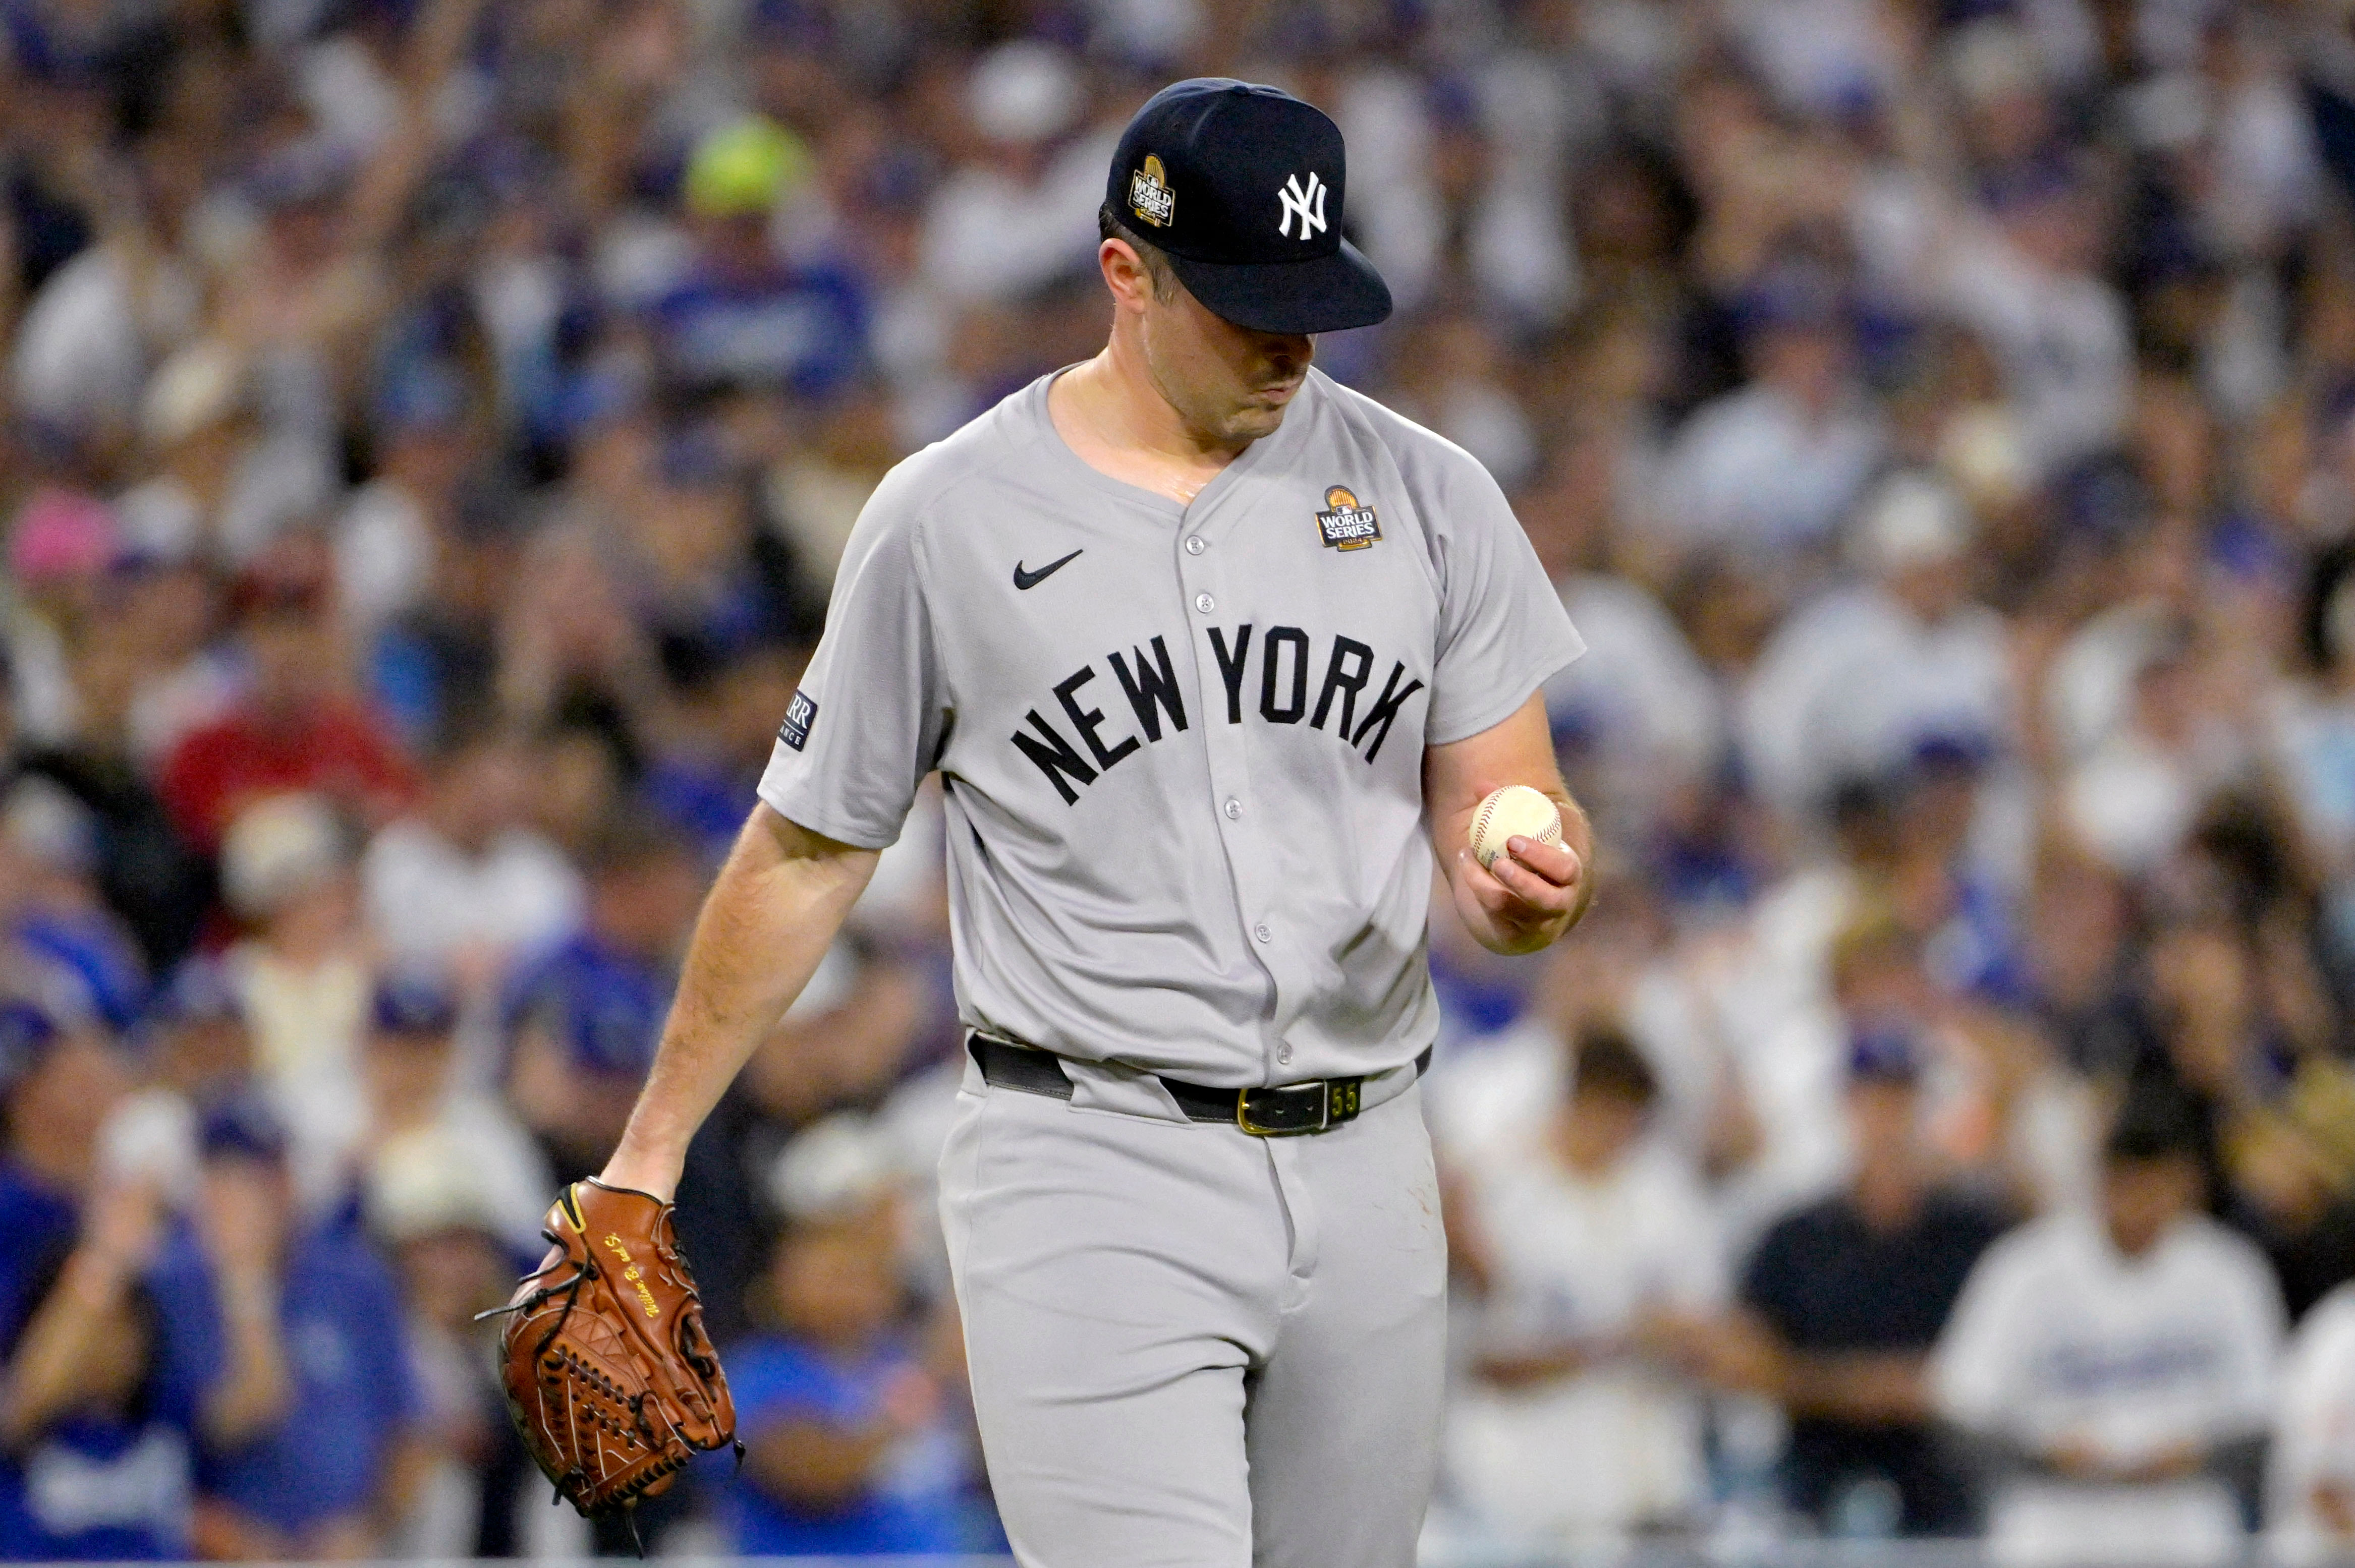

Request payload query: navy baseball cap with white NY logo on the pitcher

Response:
[1104,75,1389,332]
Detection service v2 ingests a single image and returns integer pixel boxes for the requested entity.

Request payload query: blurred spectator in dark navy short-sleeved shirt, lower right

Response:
[1719,1026,2004,1537]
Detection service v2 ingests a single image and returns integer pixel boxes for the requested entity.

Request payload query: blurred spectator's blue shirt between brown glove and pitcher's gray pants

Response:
[727,1338,973,1556]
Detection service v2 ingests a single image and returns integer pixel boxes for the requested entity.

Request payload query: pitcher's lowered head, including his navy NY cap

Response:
[1097,78,1389,445]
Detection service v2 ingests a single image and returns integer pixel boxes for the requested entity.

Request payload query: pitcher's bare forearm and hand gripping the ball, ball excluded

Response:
[1422,694,1594,954]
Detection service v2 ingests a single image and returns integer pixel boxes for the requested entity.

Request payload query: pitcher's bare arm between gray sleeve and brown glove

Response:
[603,805,876,1201]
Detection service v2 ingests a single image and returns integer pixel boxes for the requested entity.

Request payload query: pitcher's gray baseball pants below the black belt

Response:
[940,1064,1446,1568]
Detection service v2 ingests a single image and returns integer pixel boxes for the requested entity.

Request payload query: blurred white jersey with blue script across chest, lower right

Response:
[1933,1210,2282,1565]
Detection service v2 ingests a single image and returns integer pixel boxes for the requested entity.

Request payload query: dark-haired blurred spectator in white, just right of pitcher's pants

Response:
[1446,1026,1726,1544]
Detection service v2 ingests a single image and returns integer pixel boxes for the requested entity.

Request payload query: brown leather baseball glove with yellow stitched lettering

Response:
[483,1182,744,1519]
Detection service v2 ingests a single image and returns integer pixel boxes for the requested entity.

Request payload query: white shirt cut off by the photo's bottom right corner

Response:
[2266,1286,2355,1568]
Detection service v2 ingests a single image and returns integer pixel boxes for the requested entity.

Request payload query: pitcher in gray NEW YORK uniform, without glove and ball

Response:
[589,80,1590,1568]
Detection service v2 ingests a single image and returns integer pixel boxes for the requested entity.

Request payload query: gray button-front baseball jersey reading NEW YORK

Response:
[761,370,1583,1085]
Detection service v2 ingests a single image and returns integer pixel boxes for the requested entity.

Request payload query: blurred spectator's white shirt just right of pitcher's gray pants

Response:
[1443,1139,1728,1540]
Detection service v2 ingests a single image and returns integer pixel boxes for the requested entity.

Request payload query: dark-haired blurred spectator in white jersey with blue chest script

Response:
[1931,1088,2282,1563]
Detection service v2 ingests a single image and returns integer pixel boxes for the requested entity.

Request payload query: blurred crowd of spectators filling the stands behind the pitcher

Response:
[0,0,2355,1565]
